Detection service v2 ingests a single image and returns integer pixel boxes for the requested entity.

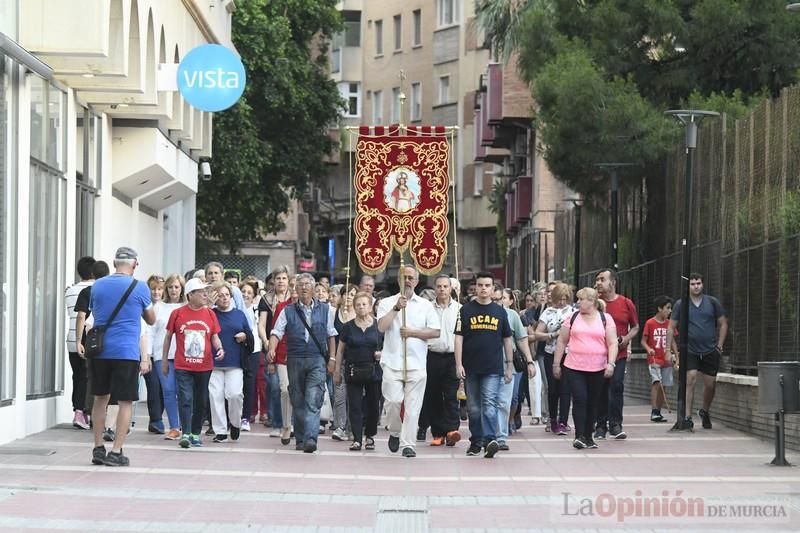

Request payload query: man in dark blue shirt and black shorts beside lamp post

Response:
[667,272,728,429]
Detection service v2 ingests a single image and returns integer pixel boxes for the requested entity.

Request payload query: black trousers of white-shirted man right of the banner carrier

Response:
[418,351,460,437]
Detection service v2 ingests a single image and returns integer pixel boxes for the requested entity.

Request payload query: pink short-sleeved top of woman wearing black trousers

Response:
[563,313,615,372]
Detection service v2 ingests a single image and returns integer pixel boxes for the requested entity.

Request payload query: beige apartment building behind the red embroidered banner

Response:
[311,0,496,288]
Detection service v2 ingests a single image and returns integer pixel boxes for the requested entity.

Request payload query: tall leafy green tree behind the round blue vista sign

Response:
[197,0,343,251]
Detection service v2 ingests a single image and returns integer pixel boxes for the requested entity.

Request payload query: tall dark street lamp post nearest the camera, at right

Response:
[664,109,719,431]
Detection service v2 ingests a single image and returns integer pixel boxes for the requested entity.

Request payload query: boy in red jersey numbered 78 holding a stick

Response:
[642,296,675,422]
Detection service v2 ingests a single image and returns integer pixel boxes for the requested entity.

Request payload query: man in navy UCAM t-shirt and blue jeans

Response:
[455,272,514,459]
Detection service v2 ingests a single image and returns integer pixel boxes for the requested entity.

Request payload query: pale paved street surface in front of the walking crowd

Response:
[0,396,800,533]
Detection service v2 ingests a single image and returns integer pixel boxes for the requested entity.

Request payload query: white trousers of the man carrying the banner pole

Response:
[381,365,428,449]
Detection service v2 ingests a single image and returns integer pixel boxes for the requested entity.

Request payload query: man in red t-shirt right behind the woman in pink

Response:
[594,269,639,440]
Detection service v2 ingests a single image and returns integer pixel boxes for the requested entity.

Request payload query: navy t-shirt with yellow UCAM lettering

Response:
[455,300,511,375]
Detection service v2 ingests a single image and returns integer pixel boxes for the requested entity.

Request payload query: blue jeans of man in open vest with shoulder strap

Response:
[286,356,328,444]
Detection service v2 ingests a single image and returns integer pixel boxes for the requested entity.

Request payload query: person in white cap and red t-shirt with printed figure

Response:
[161,278,225,448]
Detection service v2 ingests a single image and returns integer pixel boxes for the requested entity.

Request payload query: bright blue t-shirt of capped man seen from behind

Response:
[89,274,153,361]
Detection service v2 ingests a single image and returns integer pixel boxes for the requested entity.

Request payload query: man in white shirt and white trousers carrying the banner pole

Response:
[378,266,441,457]
